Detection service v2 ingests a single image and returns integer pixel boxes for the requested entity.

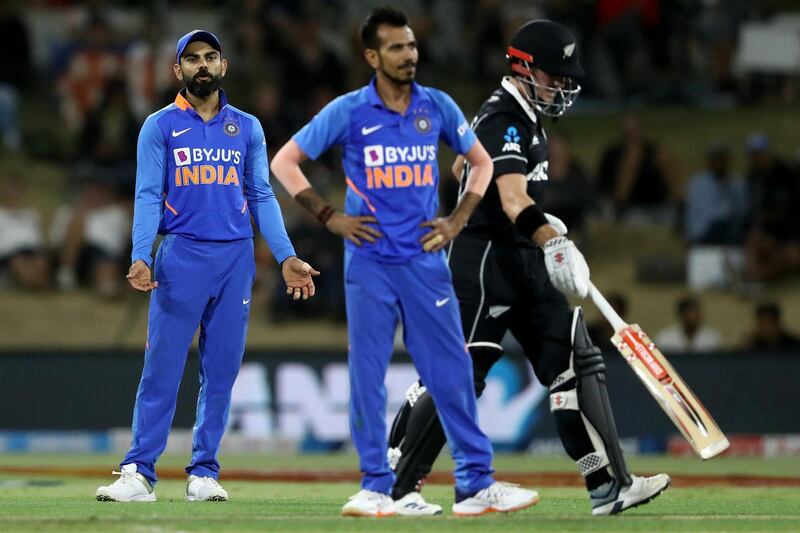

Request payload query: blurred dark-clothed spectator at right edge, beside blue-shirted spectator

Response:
[746,133,800,281]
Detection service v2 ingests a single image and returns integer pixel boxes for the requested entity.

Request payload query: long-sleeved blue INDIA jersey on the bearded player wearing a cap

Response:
[131,90,295,266]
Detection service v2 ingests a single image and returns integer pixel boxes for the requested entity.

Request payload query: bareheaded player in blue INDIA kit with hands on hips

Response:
[272,8,539,516]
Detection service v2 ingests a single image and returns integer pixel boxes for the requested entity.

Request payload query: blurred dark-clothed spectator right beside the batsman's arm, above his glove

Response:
[541,133,594,240]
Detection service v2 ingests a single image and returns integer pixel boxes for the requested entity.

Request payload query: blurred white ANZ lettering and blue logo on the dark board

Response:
[229,357,547,451]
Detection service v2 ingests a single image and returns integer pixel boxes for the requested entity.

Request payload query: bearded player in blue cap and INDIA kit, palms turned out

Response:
[96,30,319,502]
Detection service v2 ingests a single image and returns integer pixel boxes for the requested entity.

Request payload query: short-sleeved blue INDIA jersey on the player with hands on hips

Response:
[294,78,476,262]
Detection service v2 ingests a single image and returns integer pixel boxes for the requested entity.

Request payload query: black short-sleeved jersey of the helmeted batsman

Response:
[461,77,548,247]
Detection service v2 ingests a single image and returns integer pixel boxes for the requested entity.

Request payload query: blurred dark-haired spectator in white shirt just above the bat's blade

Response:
[655,296,722,353]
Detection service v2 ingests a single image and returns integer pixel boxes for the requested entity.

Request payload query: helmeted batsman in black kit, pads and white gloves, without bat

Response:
[389,20,670,515]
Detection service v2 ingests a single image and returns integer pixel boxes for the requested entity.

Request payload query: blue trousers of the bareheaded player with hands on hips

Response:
[345,252,494,495]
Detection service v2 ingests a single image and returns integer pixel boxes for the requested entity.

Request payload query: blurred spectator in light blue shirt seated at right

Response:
[684,143,748,245]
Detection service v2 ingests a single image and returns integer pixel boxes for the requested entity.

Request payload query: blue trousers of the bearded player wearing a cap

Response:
[120,235,255,484]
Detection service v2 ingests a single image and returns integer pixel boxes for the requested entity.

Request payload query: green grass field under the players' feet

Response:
[0,455,800,533]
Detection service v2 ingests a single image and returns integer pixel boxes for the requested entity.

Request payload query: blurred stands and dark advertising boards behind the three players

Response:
[0,0,800,455]
